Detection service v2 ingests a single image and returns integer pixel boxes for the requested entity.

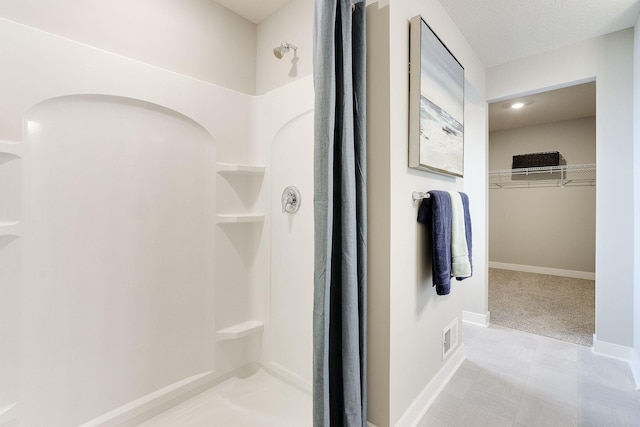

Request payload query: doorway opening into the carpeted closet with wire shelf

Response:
[489,81,596,346]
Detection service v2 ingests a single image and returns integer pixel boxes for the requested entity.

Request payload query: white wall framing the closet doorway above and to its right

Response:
[487,29,634,348]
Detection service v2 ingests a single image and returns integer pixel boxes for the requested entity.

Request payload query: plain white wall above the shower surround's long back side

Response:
[0,0,256,94]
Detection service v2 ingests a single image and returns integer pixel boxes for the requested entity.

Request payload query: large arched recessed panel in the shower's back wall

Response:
[19,95,218,426]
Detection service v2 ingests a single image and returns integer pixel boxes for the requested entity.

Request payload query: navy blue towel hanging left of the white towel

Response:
[418,190,451,295]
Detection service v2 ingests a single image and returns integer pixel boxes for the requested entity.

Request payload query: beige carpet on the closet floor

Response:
[489,268,595,346]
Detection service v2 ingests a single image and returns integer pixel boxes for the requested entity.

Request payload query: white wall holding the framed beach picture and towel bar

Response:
[367,0,487,426]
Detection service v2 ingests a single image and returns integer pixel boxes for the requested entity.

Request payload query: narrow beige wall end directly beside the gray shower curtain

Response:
[367,4,391,427]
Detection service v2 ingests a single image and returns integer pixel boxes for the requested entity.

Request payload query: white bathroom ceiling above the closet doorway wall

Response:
[440,0,640,68]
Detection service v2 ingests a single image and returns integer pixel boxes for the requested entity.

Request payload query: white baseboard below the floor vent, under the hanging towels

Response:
[395,344,467,427]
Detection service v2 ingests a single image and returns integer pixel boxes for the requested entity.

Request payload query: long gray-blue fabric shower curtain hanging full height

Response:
[313,0,367,427]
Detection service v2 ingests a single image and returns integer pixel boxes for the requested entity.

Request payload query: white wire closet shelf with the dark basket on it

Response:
[489,164,596,190]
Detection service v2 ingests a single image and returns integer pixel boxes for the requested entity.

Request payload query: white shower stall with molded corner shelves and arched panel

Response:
[0,10,313,427]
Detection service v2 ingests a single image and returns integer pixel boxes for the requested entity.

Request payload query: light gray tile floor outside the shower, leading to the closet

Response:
[419,324,640,427]
